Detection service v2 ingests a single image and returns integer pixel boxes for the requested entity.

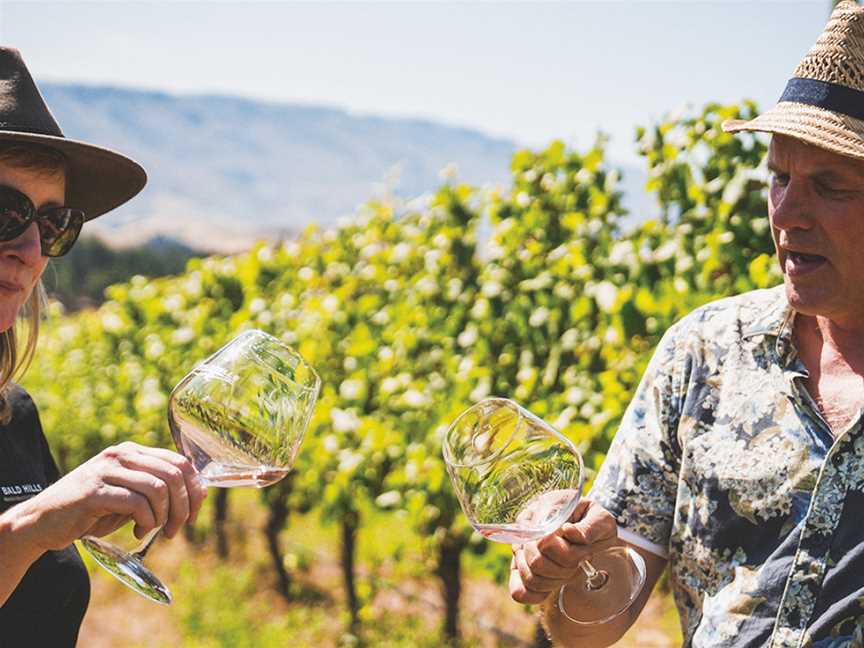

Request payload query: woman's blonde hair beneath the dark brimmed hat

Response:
[0,142,66,424]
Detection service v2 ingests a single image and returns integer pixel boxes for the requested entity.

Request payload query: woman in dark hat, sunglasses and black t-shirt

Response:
[0,48,206,647]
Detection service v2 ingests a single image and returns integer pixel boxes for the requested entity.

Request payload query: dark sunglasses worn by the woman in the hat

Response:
[0,186,84,257]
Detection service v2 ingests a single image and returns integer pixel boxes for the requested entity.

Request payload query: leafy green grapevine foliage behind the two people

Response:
[25,104,779,634]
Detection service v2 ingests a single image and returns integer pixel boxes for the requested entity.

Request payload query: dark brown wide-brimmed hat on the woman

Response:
[0,47,147,220]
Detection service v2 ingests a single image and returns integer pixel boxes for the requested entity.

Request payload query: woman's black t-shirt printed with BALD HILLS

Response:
[0,386,90,648]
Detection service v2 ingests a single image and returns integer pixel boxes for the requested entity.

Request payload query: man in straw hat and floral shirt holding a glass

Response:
[510,1,864,647]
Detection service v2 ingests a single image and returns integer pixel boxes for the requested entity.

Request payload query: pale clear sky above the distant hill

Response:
[0,0,830,161]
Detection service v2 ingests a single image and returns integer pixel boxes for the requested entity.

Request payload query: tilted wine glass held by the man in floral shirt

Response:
[443,398,645,625]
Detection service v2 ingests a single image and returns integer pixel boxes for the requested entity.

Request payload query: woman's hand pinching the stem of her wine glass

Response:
[10,442,207,551]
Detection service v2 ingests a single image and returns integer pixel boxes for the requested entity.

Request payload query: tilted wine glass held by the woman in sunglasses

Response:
[81,330,321,605]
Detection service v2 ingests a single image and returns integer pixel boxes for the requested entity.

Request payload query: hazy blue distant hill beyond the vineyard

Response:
[41,84,516,251]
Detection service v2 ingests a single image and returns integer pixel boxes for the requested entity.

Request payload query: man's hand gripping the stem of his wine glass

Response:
[510,500,618,604]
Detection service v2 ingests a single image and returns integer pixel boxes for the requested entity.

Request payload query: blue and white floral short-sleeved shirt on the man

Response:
[591,286,864,648]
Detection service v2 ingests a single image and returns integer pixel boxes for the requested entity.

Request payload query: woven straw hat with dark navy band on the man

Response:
[723,0,864,159]
